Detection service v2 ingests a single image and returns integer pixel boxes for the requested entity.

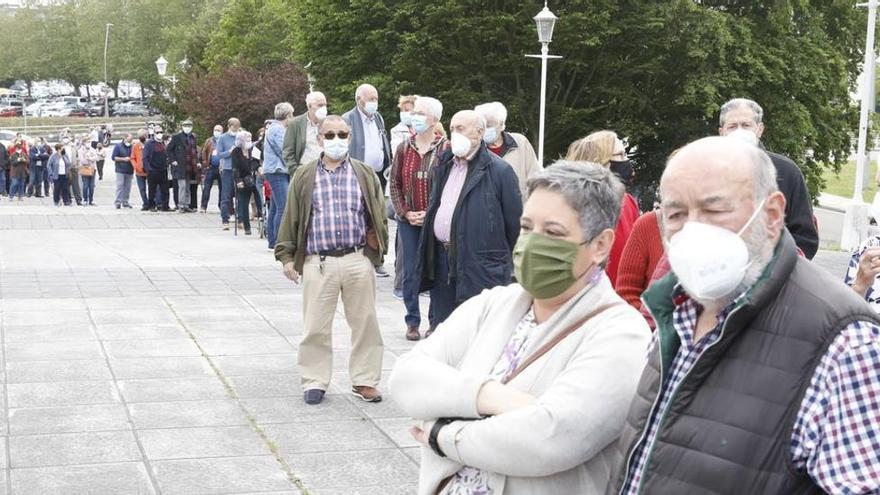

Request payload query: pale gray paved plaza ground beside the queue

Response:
[0,166,427,495]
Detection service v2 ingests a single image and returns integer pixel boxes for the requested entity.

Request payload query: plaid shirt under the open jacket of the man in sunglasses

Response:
[306,159,367,255]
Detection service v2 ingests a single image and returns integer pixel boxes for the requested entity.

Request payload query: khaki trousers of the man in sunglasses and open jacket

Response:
[297,251,383,390]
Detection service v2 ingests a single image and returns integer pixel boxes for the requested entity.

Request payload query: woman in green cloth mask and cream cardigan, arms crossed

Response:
[390,161,651,495]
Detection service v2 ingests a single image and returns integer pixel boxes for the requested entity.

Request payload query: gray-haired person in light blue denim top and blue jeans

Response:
[263,101,293,250]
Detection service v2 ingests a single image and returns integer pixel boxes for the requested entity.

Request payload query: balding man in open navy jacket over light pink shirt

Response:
[415,110,522,337]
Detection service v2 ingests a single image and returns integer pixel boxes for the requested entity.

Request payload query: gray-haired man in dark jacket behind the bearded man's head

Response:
[718,98,819,259]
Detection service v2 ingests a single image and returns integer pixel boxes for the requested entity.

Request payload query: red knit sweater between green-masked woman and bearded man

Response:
[616,211,663,309]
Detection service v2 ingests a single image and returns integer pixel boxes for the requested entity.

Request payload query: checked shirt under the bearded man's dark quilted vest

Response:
[621,292,880,495]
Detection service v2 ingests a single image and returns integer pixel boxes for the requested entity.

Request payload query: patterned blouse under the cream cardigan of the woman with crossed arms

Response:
[444,308,538,495]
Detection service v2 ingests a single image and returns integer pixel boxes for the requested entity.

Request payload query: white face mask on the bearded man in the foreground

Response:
[667,201,764,301]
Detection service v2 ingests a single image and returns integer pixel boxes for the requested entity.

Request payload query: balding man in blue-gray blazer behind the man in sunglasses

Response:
[342,84,391,277]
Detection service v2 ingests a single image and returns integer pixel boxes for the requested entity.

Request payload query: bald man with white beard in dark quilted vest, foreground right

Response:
[607,137,880,495]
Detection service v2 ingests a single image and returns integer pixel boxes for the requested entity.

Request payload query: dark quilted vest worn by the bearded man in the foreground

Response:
[608,231,880,495]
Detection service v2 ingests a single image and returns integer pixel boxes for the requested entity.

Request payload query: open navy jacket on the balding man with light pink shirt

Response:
[416,143,522,304]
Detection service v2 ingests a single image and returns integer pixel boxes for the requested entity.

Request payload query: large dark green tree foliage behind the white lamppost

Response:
[294,0,866,205]
